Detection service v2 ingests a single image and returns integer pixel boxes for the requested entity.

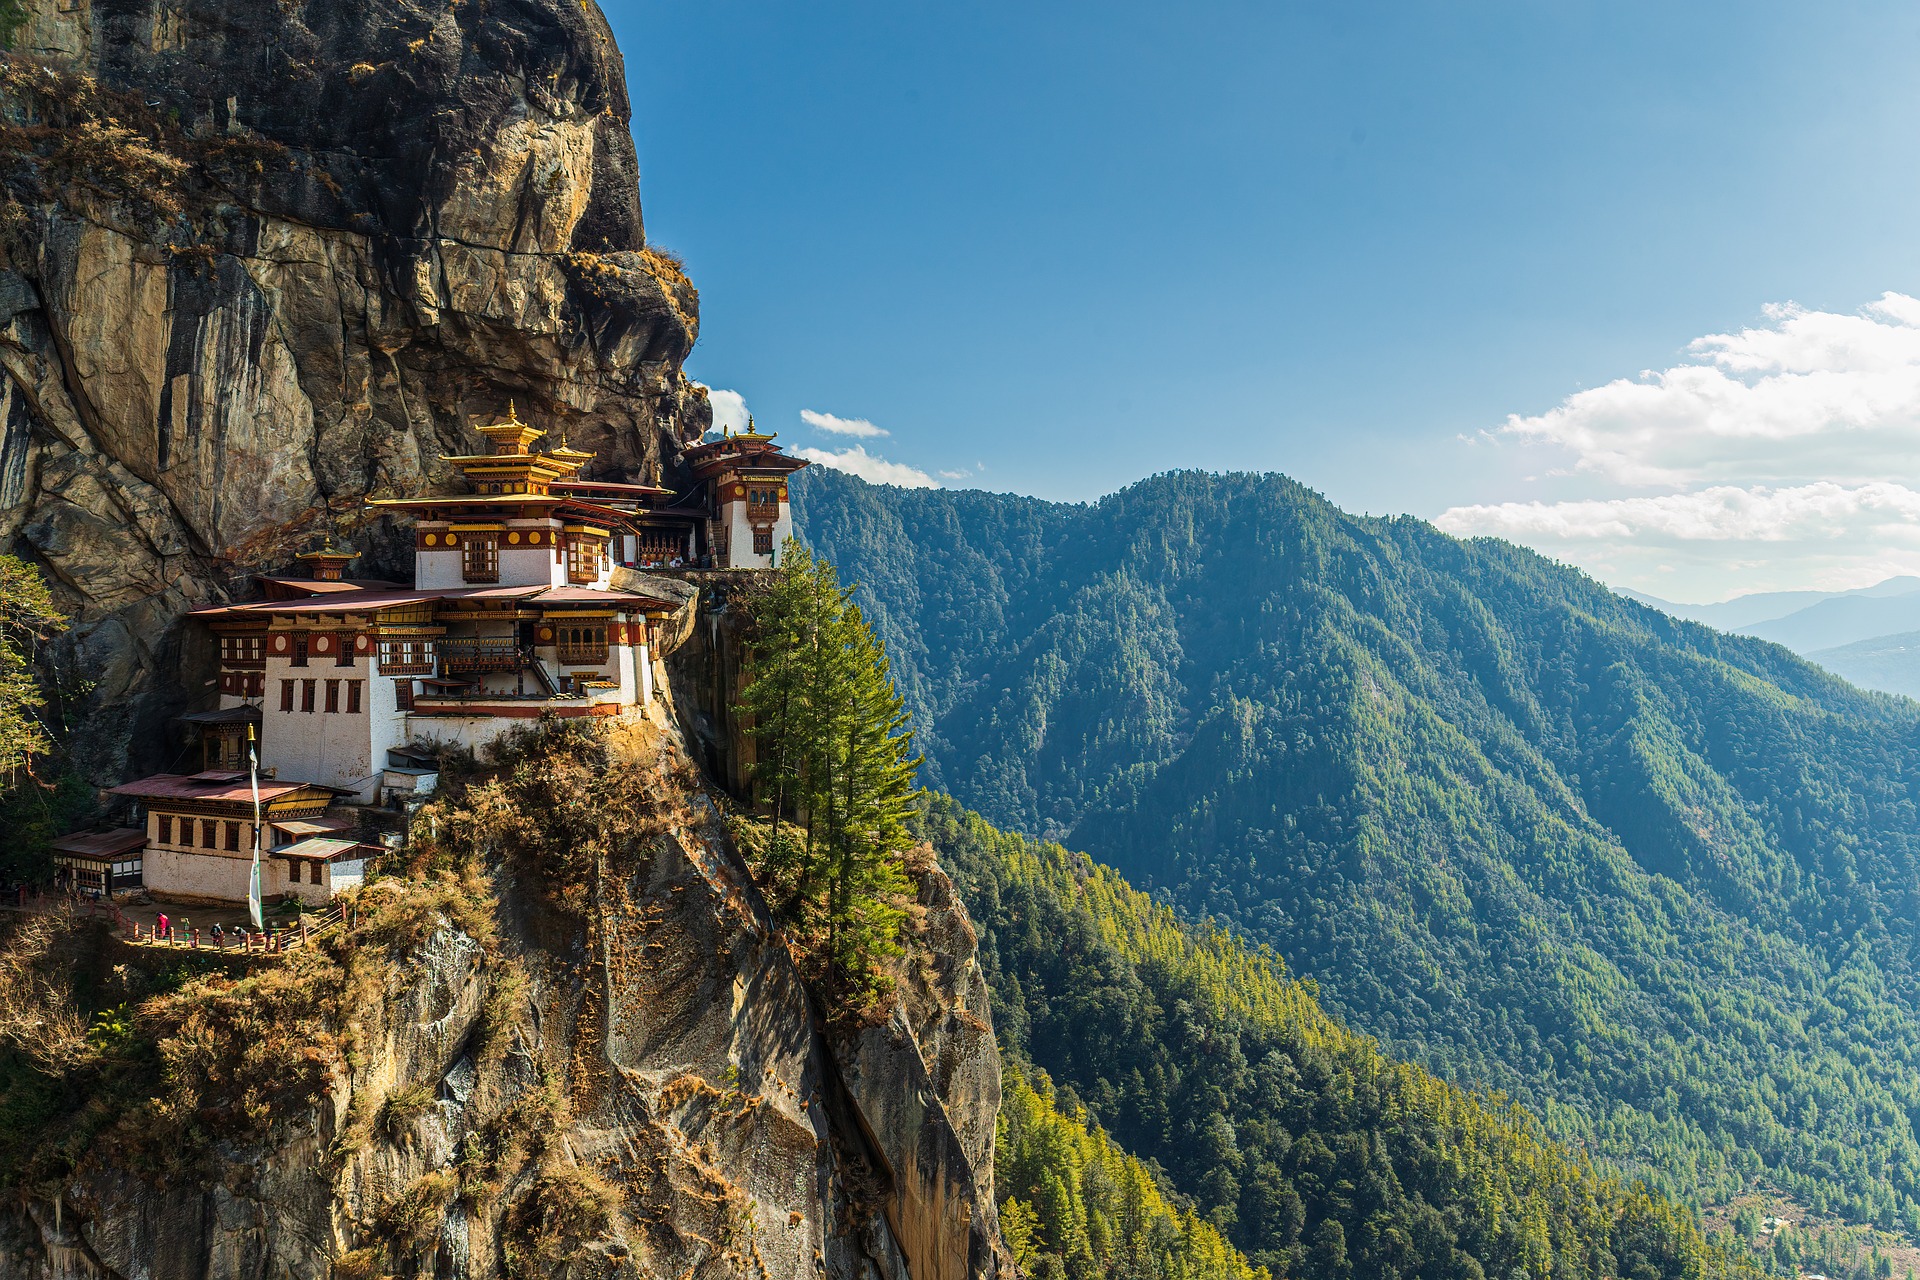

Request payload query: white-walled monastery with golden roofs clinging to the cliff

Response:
[56,407,806,904]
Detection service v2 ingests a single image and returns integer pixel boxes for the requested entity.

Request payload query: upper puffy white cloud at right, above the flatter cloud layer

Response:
[1496,294,1920,487]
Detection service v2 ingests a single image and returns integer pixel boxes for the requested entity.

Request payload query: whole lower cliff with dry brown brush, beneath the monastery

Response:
[0,723,1016,1280]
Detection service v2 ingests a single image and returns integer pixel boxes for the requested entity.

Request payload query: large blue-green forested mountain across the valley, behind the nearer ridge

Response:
[795,468,1920,1232]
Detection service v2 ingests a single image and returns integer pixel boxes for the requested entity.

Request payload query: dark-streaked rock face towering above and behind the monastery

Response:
[0,0,710,781]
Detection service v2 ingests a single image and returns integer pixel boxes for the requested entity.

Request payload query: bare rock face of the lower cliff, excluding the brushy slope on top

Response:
[0,725,1018,1280]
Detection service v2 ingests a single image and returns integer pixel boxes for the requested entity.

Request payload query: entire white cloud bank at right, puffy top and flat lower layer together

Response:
[1436,294,1920,599]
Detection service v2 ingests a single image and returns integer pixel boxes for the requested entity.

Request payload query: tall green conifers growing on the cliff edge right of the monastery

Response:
[741,541,918,1006]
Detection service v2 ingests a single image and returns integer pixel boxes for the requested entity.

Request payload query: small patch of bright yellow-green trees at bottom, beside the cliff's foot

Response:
[995,1067,1265,1280]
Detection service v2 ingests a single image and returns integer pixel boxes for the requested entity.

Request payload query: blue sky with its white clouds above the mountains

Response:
[607,0,1920,599]
